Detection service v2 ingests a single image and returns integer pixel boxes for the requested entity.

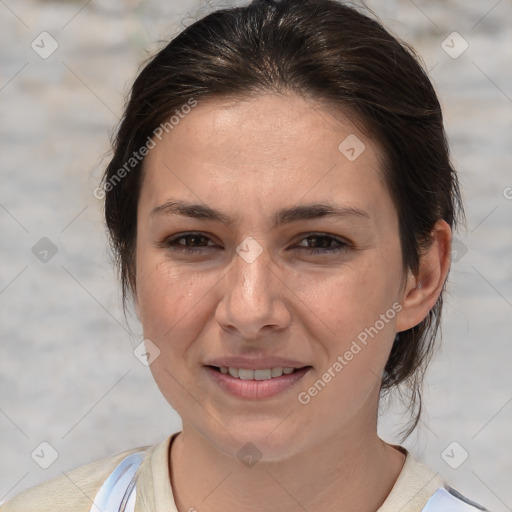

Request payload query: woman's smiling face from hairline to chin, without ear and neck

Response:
[136,94,410,460]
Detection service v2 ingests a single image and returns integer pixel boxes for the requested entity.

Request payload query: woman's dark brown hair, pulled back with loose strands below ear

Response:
[102,0,464,437]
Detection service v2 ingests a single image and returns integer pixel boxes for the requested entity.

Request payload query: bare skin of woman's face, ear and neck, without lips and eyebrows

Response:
[135,94,451,512]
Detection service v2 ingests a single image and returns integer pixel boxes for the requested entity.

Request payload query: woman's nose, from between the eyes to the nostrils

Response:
[215,240,291,340]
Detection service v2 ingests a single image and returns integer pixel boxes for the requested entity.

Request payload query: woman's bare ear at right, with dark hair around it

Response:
[396,220,452,332]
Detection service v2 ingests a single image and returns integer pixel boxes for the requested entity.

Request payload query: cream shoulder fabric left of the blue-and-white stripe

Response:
[0,446,152,512]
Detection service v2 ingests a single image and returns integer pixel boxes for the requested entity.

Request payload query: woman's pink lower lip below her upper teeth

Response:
[205,366,311,399]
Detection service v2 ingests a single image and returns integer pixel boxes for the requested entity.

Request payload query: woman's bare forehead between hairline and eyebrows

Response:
[141,94,386,224]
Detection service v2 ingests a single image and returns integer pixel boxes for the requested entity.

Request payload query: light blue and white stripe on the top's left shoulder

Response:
[89,452,145,512]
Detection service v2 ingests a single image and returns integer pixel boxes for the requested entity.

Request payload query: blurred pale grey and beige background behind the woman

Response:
[0,0,512,512]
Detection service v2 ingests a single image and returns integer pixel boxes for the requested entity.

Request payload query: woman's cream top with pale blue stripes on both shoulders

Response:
[0,432,485,512]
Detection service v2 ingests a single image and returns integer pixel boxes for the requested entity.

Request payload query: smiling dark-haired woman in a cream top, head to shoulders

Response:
[1,0,492,512]
